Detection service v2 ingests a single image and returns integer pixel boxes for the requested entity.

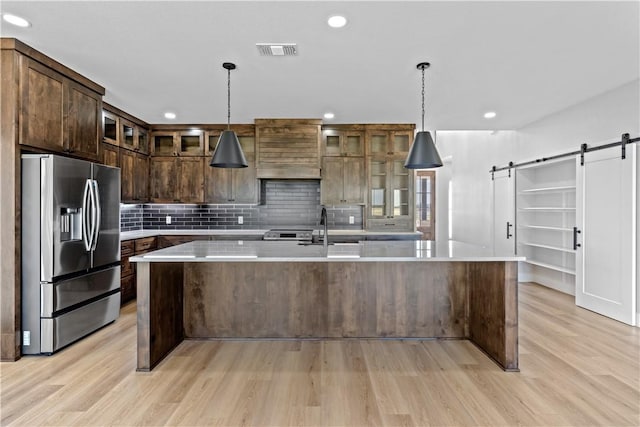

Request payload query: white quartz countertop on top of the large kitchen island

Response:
[129,240,525,262]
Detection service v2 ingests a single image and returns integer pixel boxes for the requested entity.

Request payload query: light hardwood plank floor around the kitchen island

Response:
[0,283,640,426]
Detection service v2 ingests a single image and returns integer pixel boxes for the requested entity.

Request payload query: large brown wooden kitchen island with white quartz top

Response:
[130,241,524,371]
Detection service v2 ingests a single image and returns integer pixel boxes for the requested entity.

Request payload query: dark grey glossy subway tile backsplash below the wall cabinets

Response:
[120,180,363,231]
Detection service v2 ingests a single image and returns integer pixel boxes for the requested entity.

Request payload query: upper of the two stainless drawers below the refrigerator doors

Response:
[40,265,120,317]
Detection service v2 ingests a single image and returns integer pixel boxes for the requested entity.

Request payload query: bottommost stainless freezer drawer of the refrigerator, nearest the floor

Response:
[40,292,120,353]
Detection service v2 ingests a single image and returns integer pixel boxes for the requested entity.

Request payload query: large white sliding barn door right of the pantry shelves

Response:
[576,144,637,325]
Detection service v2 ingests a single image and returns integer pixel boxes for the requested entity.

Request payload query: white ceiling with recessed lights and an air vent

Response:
[0,0,640,130]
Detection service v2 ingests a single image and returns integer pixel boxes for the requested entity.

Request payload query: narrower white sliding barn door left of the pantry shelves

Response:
[493,170,516,255]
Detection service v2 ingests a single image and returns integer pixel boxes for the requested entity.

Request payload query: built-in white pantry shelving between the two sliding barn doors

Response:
[516,157,576,292]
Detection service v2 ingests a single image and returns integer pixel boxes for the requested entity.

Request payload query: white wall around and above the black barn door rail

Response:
[436,80,640,318]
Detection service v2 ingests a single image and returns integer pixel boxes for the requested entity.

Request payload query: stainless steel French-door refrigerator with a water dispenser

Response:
[21,154,120,354]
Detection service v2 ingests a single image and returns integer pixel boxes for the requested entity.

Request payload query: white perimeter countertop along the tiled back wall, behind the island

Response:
[120,231,420,240]
